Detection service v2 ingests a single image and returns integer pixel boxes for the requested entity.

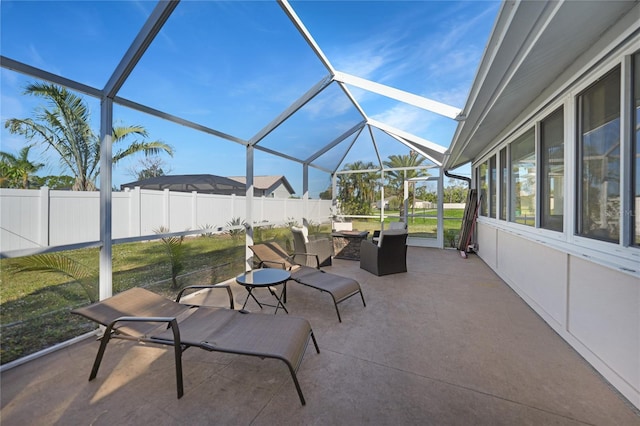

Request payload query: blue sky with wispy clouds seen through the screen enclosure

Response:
[0,0,499,197]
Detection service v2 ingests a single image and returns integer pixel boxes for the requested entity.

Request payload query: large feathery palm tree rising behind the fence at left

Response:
[4,83,173,191]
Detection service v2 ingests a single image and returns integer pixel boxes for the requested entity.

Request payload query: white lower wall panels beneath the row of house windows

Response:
[477,221,640,406]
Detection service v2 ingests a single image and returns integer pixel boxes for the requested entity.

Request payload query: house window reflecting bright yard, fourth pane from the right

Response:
[509,129,536,226]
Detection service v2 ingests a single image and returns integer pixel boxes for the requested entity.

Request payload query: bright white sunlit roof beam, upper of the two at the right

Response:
[334,71,460,119]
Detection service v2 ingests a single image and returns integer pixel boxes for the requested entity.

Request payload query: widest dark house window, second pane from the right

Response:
[576,68,620,242]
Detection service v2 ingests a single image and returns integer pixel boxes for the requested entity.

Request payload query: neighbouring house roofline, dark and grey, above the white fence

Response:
[120,174,294,196]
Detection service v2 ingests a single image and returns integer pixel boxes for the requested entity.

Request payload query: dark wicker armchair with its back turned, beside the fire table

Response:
[360,229,408,276]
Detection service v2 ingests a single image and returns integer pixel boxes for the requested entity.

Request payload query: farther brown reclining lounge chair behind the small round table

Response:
[249,242,367,322]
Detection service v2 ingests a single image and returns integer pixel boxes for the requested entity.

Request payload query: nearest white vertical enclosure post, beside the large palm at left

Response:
[100,97,113,300]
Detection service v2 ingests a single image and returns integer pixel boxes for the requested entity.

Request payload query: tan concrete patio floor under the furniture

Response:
[0,247,640,426]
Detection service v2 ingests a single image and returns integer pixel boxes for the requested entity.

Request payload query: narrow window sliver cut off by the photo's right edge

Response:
[631,52,640,246]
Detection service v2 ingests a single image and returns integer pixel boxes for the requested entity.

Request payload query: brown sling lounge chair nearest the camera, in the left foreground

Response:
[71,286,320,405]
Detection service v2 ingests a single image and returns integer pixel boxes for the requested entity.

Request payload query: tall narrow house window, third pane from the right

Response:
[540,108,564,232]
